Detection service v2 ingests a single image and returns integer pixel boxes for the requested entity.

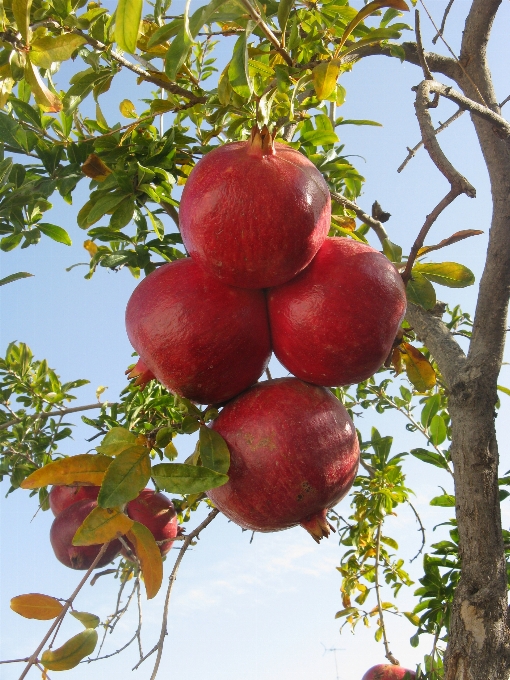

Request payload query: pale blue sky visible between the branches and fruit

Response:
[0,0,510,680]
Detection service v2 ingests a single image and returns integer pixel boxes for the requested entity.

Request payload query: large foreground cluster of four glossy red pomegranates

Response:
[126,127,406,541]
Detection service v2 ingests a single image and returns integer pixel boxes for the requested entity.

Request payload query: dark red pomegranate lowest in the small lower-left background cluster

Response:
[50,500,122,570]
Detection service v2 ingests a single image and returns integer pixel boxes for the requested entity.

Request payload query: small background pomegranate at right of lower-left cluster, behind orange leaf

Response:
[122,489,177,555]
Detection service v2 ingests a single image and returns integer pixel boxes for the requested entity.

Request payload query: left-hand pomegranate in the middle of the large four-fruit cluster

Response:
[126,258,271,404]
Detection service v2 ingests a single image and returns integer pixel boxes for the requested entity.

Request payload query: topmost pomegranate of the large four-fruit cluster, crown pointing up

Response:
[179,128,331,288]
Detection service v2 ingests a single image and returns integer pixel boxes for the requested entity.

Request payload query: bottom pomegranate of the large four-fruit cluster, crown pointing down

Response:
[208,378,359,542]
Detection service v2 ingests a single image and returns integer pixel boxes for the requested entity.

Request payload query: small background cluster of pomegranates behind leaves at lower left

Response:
[49,486,179,569]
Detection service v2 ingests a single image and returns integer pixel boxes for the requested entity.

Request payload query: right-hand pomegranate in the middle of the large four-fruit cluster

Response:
[268,238,406,386]
